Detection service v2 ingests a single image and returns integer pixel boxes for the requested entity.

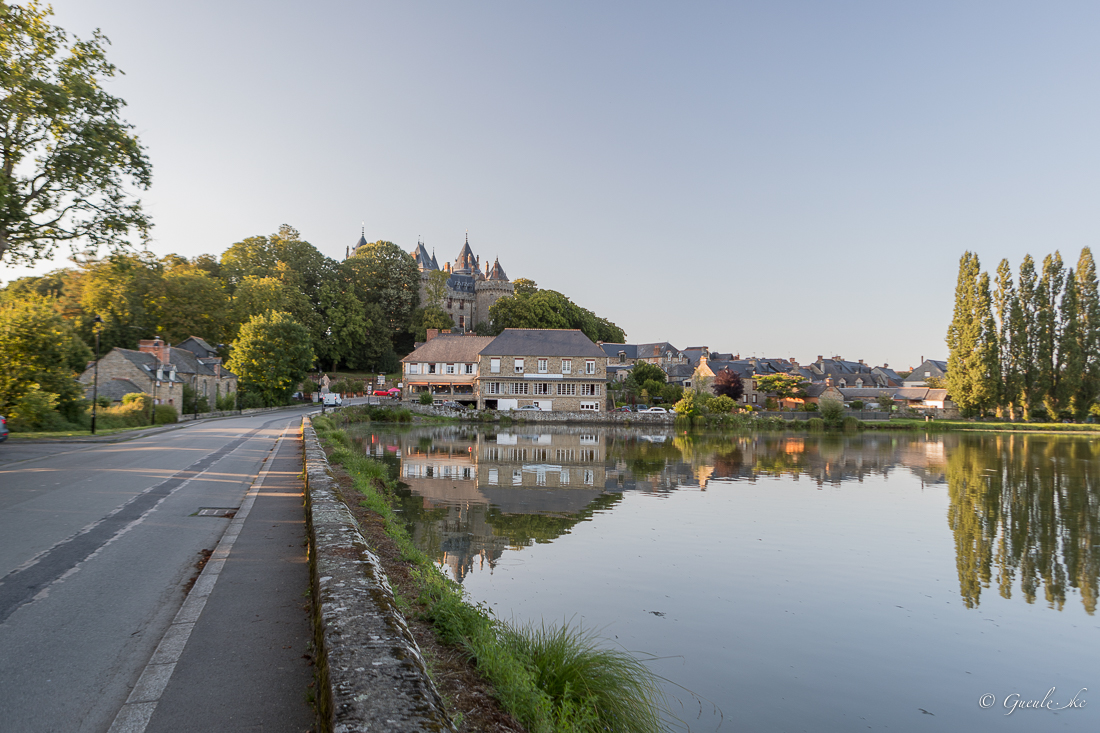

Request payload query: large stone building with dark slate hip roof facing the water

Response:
[477,328,607,412]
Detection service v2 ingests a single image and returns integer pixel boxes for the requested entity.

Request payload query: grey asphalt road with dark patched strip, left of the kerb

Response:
[0,407,314,733]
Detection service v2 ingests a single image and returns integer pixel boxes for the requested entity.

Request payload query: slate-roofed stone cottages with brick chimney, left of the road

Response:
[78,337,237,408]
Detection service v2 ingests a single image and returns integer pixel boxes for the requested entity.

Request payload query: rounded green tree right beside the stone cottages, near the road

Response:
[226,311,314,405]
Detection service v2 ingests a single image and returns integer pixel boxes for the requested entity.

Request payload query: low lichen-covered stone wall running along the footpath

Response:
[303,417,454,733]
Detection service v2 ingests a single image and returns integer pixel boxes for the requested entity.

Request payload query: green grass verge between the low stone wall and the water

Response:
[314,416,664,733]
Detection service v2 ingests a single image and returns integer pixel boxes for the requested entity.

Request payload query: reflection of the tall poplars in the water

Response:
[947,435,1100,614]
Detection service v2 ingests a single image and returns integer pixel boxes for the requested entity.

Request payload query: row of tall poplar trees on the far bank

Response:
[947,248,1100,420]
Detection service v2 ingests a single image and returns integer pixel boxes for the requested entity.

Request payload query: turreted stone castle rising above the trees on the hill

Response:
[355,234,515,331]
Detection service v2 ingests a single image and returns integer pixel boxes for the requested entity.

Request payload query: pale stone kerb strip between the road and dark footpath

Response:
[108,425,297,733]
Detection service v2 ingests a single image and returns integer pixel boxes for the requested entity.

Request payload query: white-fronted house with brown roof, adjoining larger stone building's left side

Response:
[402,329,493,405]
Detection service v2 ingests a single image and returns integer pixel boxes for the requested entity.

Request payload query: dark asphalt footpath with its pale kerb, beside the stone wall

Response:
[111,425,315,733]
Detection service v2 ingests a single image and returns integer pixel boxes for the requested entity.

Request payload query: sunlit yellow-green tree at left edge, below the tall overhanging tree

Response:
[0,296,92,427]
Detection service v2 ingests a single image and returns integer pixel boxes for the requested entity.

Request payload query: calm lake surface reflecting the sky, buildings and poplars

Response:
[349,427,1100,731]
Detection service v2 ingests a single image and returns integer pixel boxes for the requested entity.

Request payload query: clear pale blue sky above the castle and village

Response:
[0,0,1100,368]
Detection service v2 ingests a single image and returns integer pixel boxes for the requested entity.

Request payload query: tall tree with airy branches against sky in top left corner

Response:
[0,2,152,263]
